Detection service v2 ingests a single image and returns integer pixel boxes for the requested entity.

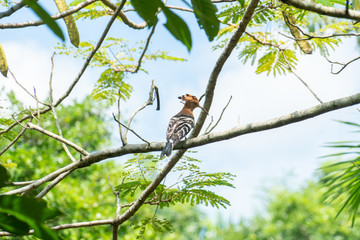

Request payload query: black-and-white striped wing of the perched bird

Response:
[166,115,194,145]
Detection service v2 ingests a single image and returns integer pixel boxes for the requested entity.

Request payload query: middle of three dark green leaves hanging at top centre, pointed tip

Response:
[162,6,192,51]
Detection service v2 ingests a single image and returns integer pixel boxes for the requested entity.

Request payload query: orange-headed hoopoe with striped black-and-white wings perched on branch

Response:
[160,94,207,158]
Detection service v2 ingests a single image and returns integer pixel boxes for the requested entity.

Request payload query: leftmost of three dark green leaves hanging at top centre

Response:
[131,0,163,27]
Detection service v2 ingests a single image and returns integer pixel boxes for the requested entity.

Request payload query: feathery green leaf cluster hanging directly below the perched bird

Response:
[115,154,234,236]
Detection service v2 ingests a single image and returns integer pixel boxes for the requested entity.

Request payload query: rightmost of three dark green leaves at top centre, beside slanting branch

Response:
[191,0,220,41]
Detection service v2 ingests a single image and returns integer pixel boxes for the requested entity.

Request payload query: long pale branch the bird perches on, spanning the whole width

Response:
[3,93,360,195]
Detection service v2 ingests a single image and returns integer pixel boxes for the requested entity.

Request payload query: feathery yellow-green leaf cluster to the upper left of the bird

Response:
[55,37,185,104]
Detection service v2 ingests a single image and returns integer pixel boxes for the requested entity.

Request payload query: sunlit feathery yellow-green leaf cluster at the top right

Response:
[214,0,356,76]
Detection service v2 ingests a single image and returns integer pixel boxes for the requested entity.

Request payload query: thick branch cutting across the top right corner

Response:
[281,0,360,21]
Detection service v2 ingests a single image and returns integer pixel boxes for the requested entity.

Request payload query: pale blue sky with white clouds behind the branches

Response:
[0,1,360,221]
